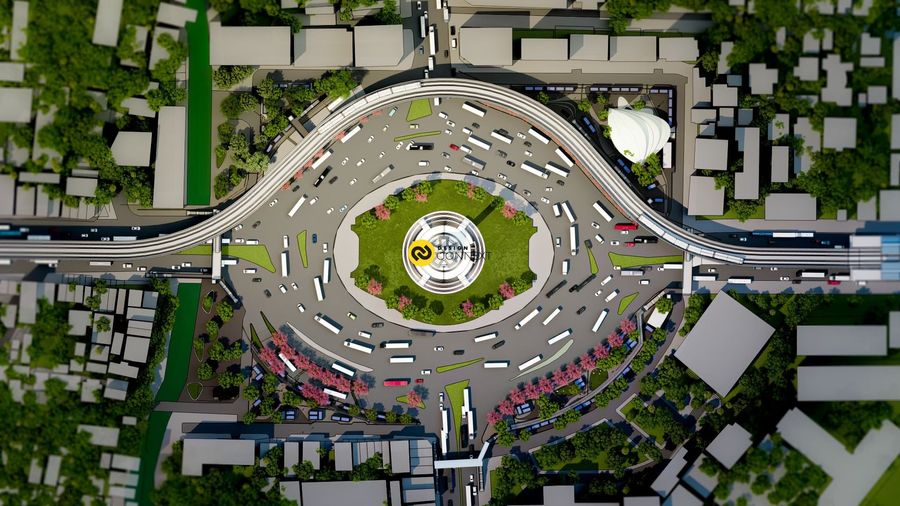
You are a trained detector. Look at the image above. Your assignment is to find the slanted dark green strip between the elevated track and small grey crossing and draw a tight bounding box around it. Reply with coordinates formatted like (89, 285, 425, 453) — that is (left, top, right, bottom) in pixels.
(156, 283, 200, 402)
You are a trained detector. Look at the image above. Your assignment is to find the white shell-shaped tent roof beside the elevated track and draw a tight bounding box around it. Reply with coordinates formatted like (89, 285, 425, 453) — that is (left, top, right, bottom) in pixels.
(609, 109, 672, 163)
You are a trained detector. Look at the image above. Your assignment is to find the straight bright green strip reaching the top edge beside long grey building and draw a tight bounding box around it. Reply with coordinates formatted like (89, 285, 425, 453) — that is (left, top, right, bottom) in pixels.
(187, 0, 212, 206)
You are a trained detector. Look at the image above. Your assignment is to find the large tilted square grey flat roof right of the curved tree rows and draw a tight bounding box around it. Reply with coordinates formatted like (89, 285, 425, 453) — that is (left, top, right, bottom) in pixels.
(675, 292, 775, 397)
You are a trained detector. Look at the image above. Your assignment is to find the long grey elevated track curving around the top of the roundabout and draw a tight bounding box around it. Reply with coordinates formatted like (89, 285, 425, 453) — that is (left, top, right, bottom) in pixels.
(0, 79, 887, 269)
